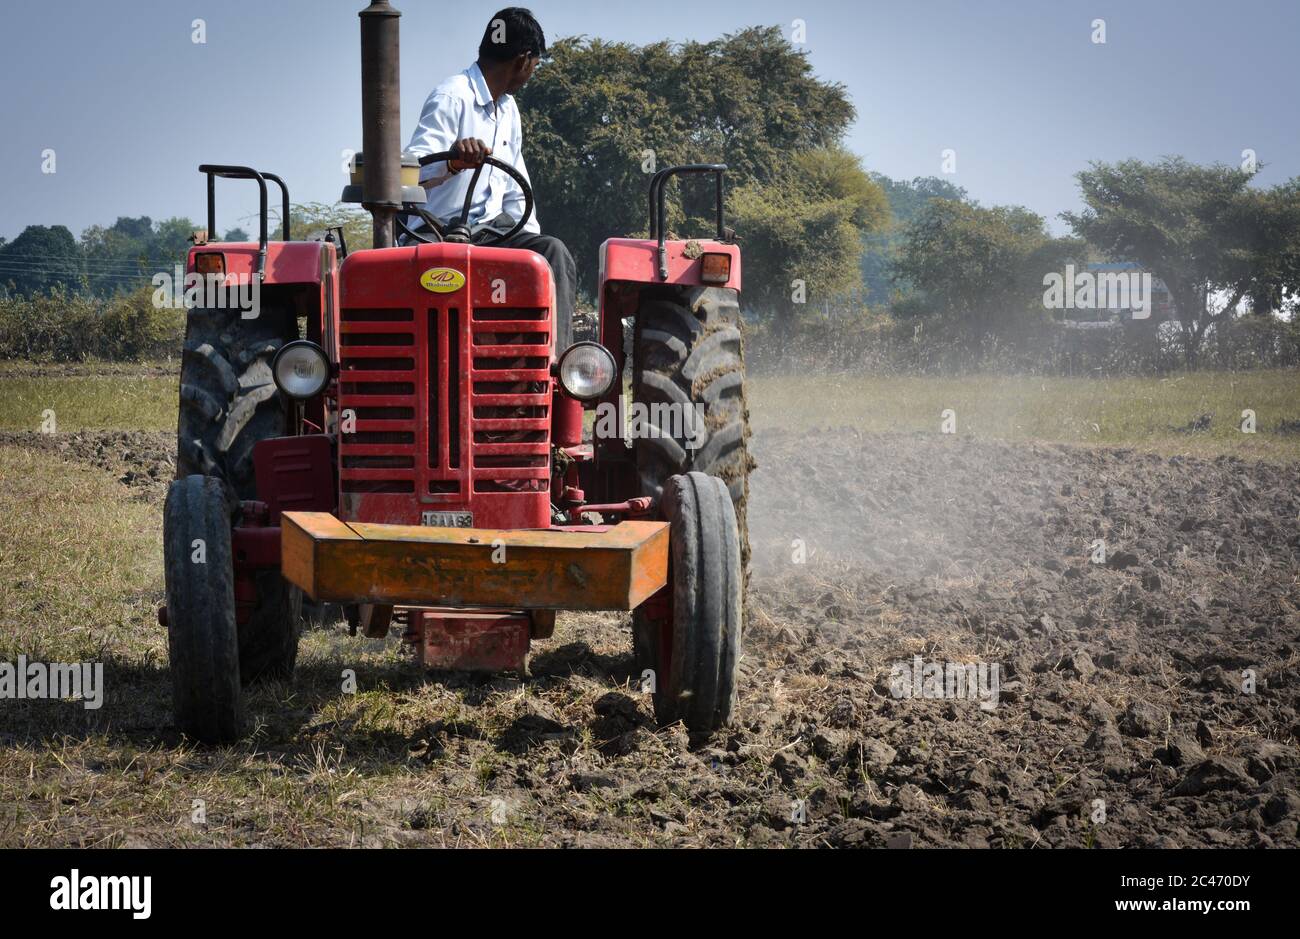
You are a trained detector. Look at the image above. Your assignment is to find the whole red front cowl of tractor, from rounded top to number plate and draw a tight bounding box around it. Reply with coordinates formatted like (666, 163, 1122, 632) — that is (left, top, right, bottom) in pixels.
(338, 245, 554, 528)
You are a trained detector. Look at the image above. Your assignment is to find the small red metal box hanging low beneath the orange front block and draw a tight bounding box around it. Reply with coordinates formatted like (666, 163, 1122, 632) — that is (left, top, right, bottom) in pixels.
(402, 610, 530, 672)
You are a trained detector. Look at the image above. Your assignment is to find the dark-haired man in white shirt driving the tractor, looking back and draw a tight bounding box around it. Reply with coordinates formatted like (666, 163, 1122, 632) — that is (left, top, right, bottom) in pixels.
(407, 7, 577, 349)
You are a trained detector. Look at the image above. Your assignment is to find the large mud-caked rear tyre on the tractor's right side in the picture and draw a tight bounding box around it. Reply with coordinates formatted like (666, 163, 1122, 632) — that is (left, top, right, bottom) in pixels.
(632, 287, 754, 571)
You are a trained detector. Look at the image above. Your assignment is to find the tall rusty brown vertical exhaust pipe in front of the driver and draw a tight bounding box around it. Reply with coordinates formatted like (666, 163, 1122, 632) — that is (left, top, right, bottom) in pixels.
(358, 0, 402, 248)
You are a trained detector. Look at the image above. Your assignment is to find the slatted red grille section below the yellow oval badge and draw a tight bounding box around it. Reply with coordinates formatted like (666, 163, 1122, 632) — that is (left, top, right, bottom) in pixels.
(339, 307, 551, 520)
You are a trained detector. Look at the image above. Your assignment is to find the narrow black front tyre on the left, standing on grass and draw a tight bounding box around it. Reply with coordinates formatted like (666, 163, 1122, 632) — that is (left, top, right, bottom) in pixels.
(163, 476, 243, 744)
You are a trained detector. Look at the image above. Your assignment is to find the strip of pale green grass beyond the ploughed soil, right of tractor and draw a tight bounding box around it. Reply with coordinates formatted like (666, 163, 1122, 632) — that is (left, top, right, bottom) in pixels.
(749, 369, 1300, 460)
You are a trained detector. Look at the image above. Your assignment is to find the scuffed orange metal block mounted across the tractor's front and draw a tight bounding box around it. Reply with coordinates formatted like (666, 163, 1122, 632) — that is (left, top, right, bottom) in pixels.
(281, 512, 668, 610)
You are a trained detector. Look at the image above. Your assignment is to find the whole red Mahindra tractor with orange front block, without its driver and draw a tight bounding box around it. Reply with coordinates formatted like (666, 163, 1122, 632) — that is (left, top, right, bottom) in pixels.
(161, 0, 751, 743)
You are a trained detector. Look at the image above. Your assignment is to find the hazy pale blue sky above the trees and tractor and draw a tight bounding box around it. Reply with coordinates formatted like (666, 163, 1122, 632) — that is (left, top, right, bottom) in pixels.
(0, 0, 1300, 238)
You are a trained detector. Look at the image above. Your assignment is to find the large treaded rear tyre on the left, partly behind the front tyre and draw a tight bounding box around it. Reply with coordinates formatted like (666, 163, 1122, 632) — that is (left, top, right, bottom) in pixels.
(176, 300, 303, 684)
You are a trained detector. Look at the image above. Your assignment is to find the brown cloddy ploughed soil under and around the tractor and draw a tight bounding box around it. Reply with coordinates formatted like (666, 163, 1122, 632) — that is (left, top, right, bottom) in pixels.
(0, 429, 1300, 848)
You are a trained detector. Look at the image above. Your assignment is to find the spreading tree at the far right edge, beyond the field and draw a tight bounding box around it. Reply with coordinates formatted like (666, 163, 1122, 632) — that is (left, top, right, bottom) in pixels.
(1062, 157, 1300, 365)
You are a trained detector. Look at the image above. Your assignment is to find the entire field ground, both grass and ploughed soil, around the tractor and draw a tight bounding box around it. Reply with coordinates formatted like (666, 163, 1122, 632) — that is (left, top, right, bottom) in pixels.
(0, 364, 1300, 848)
